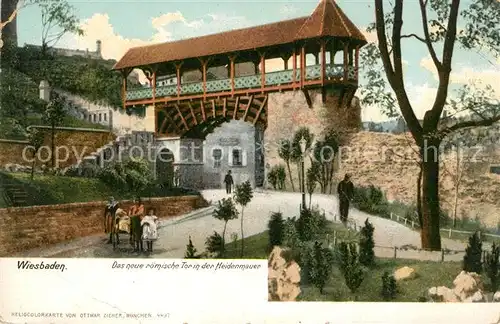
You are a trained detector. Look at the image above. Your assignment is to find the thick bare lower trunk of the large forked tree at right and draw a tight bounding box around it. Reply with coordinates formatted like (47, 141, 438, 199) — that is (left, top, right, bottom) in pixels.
(420, 139, 441, 251)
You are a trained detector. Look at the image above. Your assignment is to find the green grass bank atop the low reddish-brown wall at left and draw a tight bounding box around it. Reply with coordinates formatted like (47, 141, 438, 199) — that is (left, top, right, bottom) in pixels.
(0, 172, 198, 207)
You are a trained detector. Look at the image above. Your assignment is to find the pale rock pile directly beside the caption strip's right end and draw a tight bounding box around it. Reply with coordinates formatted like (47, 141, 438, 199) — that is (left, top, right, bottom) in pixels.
(268, 246, 300, 301)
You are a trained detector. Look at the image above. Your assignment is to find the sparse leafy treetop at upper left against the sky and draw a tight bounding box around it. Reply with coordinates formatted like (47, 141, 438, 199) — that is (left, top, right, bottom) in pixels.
(39, 0, 84, 54)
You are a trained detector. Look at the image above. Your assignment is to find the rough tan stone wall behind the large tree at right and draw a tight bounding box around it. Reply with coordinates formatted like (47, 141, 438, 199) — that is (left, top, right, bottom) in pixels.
(337, 132, 500, 226)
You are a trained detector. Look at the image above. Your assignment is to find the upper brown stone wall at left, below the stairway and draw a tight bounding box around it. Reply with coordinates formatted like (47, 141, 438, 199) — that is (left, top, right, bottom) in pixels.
(0, 127, 116, 168)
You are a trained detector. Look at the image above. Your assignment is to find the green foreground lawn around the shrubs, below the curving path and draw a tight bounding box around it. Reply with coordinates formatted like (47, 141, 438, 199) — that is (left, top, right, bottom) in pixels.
(226, 227, 462, 302)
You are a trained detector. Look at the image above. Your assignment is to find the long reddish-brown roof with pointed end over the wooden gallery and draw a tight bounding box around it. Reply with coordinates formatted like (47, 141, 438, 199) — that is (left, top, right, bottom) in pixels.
(113, 0, 366, 69)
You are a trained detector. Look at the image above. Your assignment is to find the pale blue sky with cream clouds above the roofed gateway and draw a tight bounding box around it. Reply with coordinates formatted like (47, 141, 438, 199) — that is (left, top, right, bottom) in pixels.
(13, 0, 500, 121)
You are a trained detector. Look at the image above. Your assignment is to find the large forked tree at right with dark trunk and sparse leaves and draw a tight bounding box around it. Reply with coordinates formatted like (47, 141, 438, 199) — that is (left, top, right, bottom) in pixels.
(361, 0, 500, 250)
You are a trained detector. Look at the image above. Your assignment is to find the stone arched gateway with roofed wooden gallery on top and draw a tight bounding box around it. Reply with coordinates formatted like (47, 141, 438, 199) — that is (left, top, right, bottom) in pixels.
(114, 0, 366, 187)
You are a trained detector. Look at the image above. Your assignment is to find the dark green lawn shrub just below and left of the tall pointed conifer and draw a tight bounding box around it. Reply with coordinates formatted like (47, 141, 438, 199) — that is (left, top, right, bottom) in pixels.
(339, 242, 364, 293)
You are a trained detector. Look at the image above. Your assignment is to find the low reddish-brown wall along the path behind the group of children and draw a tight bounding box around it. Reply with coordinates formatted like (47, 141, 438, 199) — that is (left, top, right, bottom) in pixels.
(0, 196, 207, 257)
